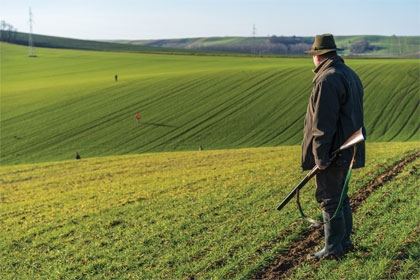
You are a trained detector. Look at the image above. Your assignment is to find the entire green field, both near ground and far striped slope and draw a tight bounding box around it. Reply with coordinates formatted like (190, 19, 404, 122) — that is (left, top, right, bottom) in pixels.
(0, 43, 420, 279)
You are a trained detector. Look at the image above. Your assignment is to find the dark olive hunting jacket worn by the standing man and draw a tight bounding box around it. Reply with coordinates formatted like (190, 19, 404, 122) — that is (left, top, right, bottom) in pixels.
(302, 56, 366, 170)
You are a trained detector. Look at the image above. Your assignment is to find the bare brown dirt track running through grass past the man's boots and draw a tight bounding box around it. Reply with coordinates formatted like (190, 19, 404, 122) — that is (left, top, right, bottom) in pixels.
(255, 152, 420, 279)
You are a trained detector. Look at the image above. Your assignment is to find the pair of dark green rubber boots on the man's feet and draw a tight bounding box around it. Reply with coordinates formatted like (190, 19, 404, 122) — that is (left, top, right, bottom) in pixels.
(308, 211, 346, 260)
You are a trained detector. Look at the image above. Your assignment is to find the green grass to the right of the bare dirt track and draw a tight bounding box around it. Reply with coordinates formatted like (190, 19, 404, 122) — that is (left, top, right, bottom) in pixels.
(292, 153, 420, 279)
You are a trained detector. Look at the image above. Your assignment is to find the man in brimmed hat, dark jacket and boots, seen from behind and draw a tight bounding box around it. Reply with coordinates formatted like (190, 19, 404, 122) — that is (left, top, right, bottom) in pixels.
(302, 34, 366, 260)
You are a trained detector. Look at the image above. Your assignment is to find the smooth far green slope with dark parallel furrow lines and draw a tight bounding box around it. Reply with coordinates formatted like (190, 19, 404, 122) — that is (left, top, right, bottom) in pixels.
(0, 43, 419, 165)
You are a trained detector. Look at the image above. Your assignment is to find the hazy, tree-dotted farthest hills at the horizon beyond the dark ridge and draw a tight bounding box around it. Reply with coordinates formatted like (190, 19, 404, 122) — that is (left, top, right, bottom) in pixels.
(122, 35, 420, 58)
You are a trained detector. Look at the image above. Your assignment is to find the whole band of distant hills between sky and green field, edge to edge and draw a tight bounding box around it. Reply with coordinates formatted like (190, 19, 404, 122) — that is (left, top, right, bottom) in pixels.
(0, 30, 420, 58)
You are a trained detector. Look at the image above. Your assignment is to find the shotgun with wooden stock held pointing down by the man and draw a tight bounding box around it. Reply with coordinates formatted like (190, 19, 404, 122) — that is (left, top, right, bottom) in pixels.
(277, 128, 365, 210)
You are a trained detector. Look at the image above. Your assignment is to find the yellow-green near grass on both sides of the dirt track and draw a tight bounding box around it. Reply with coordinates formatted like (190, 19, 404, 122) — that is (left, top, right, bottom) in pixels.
(0, 142, 420, 279)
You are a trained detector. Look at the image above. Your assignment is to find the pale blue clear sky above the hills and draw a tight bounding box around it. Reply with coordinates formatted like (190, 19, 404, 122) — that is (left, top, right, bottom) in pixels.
(0, 0, 420, 40)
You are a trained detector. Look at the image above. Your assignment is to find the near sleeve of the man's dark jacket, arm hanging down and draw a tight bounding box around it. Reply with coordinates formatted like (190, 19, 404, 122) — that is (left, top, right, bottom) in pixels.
(311, 77, 343, 166)
